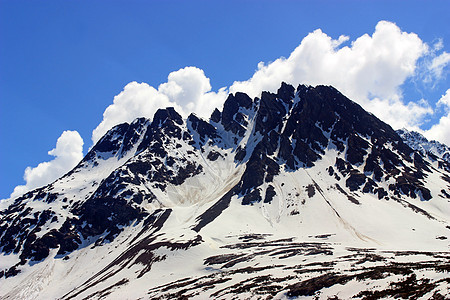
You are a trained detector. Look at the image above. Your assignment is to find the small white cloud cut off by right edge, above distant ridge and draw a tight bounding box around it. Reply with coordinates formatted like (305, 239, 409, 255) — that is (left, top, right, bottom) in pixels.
(424, 89, 450, 145)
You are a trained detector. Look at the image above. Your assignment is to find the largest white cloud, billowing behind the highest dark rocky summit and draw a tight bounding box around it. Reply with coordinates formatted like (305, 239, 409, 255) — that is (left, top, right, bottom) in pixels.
(230, 21, 431, 127)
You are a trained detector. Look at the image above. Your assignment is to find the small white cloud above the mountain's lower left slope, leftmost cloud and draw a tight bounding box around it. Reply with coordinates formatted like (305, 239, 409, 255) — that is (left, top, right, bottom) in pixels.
(11, 130, 83, 198)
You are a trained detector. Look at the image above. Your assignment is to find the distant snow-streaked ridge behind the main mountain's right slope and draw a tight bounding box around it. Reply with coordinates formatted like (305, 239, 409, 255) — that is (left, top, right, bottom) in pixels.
(397, 128, 450, 162)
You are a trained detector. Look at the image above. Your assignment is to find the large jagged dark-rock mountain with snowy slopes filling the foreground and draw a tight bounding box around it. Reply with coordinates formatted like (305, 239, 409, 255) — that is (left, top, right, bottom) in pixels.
(0, 83, 450, 299)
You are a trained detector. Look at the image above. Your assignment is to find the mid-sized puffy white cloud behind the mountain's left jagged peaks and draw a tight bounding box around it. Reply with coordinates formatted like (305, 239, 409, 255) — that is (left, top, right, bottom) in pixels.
(92, 67, 227, 144)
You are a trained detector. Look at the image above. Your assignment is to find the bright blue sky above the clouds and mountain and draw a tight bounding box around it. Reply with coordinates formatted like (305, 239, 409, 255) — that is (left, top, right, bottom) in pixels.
(0, 0, 450, 199)
